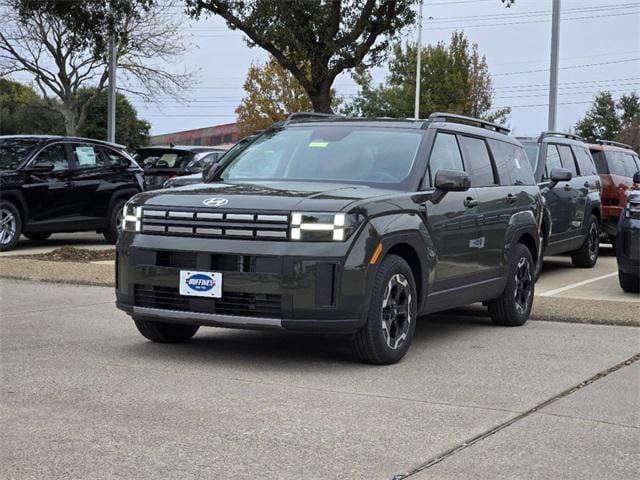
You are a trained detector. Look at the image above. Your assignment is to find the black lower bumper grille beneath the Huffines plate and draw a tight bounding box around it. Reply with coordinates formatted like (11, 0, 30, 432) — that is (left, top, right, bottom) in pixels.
(134, 285, 282, 318)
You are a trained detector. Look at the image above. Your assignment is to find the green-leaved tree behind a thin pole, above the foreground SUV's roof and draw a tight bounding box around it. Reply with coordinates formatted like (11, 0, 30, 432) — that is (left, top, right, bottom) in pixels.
(344, 32, 511, 122)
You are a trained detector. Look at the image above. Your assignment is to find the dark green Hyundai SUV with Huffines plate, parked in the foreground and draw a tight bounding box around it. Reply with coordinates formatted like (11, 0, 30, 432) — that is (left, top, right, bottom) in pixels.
(116, 113, 542, 364)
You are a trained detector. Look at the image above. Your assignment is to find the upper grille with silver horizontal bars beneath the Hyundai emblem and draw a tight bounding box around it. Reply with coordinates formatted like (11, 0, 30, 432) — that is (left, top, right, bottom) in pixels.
(142, 208, 289, 240)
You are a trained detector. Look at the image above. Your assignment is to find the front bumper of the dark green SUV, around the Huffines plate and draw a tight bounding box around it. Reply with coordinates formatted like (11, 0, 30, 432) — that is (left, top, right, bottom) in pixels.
(116, 233, 371, 332)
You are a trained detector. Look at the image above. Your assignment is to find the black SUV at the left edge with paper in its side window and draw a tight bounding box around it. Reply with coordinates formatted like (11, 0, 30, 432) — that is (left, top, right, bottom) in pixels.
(0, 135, 143, 251)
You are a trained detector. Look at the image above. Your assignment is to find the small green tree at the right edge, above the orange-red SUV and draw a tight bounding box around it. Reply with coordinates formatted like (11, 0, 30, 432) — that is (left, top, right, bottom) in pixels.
(575, 91, 640, 150)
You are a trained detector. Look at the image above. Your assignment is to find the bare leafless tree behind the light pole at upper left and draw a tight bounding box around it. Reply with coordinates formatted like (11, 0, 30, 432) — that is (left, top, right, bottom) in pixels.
(0, 1, 193, 135)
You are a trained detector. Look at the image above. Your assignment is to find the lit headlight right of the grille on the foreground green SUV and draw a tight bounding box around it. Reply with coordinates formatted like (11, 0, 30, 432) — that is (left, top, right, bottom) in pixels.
(290, 212, 364, 242)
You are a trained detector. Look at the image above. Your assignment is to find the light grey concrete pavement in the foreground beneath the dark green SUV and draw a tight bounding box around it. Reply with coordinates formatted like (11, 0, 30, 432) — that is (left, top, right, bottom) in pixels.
(0, 280, 640, 479)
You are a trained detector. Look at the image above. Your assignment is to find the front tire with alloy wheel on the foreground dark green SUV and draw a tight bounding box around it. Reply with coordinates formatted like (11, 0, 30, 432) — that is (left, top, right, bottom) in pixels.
(354, 255, 418, 365)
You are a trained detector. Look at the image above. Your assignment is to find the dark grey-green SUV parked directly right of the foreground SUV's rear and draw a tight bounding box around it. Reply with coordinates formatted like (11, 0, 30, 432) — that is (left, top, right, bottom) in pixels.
(519, 132, 602, 268)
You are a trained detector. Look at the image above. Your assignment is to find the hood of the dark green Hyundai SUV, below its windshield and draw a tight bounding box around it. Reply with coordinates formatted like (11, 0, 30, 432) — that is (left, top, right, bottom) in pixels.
(136, 182, 398, 212)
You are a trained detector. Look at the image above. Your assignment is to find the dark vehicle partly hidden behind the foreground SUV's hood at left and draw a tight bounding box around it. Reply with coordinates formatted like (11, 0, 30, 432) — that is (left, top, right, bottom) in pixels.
(133, 145, 227, 190)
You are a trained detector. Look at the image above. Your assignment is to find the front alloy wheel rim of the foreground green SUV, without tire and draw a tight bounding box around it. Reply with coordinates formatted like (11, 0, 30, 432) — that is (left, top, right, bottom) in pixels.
(382, 273, 413, 350)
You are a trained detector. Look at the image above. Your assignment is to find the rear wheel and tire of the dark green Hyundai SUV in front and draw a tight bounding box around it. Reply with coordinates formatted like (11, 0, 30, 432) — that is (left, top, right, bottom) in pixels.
(487, 243, 535, 327)
